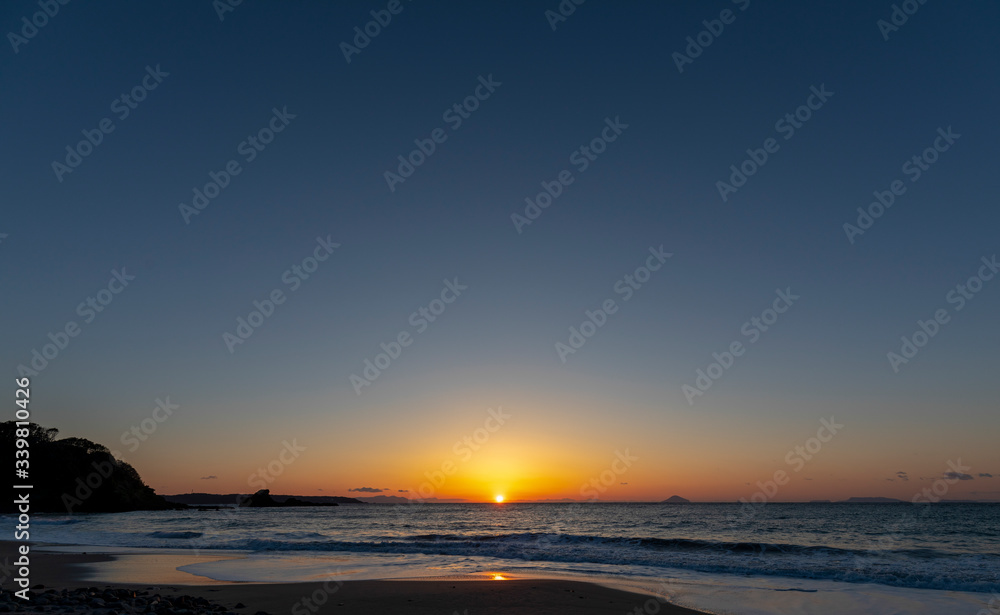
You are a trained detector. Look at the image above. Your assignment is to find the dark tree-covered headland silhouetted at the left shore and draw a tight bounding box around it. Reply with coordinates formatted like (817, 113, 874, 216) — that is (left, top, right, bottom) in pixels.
(0, 421, 176, 513)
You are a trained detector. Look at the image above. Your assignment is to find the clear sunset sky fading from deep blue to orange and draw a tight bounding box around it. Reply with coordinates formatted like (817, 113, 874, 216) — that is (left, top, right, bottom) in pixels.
(0, 0, 1000, 501)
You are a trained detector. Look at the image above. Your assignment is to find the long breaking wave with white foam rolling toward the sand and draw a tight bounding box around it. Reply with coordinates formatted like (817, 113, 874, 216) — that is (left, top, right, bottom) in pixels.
(160, 533, 1000, 592)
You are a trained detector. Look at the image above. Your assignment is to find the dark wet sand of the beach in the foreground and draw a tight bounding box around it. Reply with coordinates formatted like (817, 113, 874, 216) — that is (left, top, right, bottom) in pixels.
(0, 542, 699, 615)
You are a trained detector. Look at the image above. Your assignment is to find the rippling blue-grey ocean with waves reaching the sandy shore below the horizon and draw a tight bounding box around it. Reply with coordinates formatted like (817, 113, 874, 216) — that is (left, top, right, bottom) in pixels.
(17, 503, 1000, 615)
